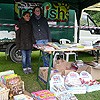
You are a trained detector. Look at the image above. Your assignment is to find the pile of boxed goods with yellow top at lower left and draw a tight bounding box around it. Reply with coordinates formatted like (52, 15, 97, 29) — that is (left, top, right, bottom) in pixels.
(0, 70, 24, 100)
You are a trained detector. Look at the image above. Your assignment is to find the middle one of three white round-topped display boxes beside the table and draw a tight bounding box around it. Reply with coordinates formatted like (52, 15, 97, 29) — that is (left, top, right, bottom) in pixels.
(64, 72, 86, 94)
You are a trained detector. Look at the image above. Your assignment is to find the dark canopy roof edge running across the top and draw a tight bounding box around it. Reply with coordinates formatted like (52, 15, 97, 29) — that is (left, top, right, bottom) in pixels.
(0, 0, 100, 24)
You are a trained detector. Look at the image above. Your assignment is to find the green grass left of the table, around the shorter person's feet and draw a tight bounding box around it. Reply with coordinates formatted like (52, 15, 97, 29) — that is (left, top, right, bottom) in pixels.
(0, 51, 41, 93)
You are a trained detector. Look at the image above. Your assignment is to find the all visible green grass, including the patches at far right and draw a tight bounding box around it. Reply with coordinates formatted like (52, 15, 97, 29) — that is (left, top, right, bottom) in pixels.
(0, 51, 100, 100)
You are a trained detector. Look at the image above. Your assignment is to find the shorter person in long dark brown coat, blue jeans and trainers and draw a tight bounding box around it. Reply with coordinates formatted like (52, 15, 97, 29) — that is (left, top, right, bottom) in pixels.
(15, 11, 33, 74)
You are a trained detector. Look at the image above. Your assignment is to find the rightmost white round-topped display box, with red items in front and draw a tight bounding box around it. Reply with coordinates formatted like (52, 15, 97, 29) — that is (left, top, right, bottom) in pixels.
(80, 71, 100, 92)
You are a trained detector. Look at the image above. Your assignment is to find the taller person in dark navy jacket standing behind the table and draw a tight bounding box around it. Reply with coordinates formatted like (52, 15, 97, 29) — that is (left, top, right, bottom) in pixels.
(31, 6, 51, 67)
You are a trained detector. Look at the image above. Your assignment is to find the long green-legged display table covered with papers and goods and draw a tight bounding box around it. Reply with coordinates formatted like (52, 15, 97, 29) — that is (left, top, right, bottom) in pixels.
(33, 42, 100, 89)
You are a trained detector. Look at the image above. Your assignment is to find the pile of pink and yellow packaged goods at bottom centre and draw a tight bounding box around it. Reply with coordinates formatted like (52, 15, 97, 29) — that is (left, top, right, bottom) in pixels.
(31, 90, 57, 100)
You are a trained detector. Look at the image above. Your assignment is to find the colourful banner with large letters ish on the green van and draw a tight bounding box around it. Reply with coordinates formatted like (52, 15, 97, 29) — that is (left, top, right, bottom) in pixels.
(15, 2, 69, 21)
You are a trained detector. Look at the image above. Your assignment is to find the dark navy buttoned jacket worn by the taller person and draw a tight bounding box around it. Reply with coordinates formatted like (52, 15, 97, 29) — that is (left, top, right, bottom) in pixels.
(31, 15, 51, 41)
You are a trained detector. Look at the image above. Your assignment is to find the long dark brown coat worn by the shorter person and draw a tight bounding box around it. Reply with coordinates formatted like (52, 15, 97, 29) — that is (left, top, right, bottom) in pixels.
(16, 18, 33, 50)
